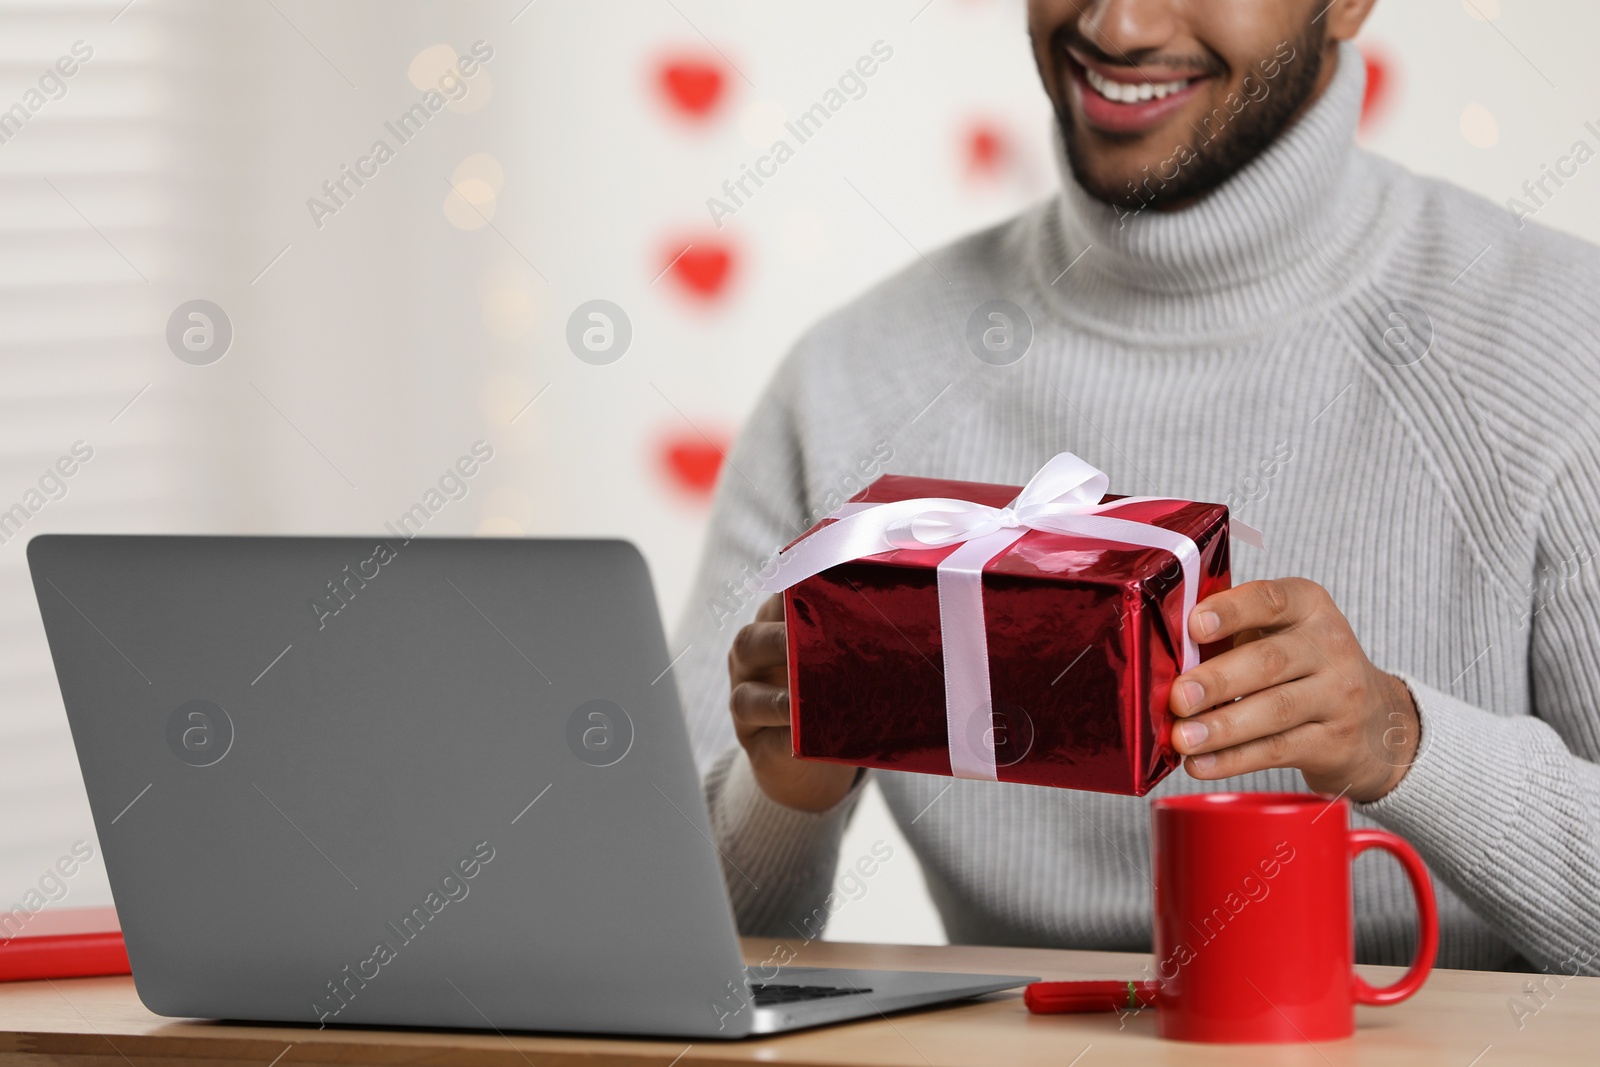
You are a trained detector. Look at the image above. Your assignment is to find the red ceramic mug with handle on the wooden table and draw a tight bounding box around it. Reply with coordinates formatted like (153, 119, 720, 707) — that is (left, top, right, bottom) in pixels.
(1150, 793, 1438, 1043)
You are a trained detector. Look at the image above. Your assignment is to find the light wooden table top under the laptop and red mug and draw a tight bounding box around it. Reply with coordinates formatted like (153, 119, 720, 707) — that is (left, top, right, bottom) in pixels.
(0, 939, 1600, 1067)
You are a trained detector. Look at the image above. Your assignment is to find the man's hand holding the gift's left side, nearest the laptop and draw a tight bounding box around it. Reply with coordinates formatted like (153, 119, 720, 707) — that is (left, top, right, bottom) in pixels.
(728, 597, 856, 811)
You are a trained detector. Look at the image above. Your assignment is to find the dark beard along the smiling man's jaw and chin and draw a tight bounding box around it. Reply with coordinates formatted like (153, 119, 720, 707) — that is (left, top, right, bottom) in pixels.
(1056, 22, 1326, 210)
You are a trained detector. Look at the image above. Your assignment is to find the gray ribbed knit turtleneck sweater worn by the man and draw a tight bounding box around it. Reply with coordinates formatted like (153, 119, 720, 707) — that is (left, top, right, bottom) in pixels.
(677, 46, 1600, 971)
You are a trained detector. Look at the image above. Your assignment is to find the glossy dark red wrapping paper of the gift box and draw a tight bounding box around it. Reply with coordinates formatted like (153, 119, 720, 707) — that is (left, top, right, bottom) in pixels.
(784, 475, 1230, 797)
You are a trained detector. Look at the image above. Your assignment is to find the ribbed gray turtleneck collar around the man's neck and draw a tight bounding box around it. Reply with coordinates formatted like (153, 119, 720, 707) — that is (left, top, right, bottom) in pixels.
(1035, 43, 1384, 336)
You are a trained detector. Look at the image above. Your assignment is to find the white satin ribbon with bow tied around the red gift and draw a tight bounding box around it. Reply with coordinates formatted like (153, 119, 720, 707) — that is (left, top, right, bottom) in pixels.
(758, 453, 1200, 781)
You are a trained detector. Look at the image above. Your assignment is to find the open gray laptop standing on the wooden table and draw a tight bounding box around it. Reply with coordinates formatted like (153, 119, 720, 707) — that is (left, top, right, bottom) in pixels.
(27, 534, 1034, 1040)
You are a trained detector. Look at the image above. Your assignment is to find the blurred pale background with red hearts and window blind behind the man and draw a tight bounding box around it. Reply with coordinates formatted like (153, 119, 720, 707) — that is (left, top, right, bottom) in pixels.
(0, 0, 1600, 944)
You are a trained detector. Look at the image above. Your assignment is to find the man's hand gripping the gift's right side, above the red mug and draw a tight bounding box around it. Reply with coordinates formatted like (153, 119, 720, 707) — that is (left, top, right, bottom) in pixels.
(1170, 577, 1421, 801)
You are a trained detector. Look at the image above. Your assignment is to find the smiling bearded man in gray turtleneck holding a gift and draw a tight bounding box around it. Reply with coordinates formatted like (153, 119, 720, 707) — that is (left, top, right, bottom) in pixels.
(678, 0, 1600, 971)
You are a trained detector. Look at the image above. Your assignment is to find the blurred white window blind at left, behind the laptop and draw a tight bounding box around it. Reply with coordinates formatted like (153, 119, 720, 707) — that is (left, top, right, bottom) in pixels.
(0, 0, 208, 909)
